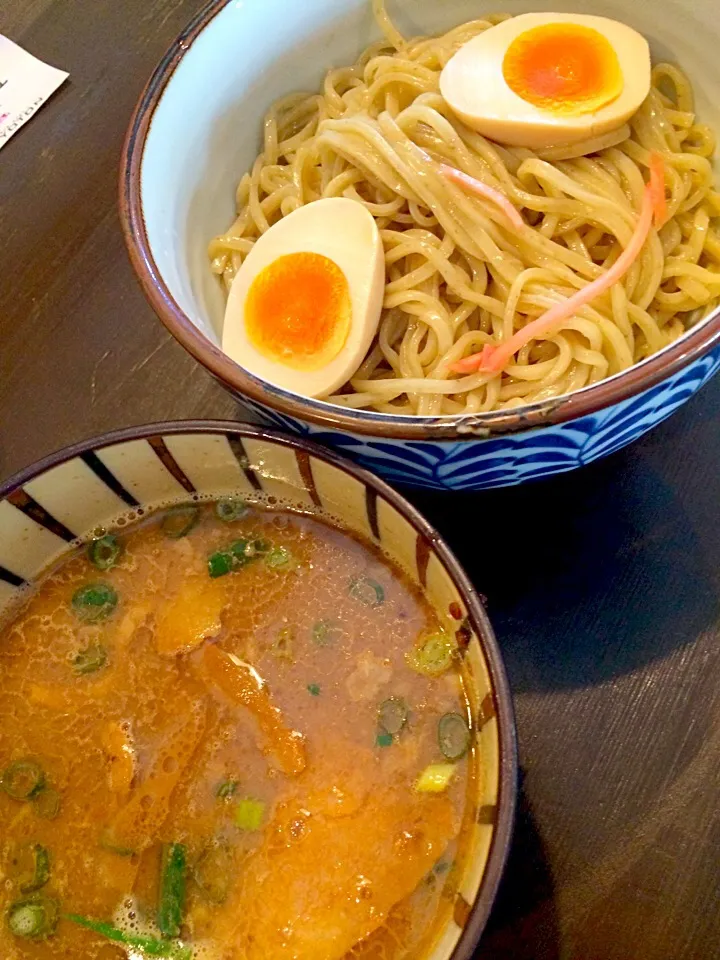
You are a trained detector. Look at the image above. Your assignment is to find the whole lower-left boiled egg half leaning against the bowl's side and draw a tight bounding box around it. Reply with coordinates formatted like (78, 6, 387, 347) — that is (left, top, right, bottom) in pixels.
(222, 197, 385, 397)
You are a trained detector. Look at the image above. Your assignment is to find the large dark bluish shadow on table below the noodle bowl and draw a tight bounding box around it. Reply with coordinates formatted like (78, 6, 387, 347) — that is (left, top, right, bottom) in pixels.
(408, 438, 718, 692)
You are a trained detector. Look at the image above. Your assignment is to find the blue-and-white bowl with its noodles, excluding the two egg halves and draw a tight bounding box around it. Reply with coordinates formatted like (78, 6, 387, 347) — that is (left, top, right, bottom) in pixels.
(120, 0, 720, 489)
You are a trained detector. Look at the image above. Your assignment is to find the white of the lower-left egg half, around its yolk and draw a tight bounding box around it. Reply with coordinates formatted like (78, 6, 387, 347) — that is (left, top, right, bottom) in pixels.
(222, 197, 385, 397)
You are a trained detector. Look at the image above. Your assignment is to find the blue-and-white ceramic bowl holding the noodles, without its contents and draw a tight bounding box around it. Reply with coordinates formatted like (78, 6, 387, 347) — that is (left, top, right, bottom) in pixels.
(120, 0, 720, 490)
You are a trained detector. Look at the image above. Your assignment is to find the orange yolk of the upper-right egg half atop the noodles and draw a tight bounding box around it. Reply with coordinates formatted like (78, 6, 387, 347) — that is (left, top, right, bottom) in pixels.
(503, 23, 623, 115)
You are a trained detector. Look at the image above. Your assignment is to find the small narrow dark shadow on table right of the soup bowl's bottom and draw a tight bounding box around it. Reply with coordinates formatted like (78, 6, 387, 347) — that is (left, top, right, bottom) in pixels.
(474, 788, 560, 960)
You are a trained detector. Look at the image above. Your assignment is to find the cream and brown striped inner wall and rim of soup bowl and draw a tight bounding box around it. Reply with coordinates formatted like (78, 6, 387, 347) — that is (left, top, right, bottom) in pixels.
(0, 422, 517, 960)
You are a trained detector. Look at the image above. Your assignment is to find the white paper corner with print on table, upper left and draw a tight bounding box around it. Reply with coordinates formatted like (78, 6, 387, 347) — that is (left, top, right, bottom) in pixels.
(0, 34, 68, 147)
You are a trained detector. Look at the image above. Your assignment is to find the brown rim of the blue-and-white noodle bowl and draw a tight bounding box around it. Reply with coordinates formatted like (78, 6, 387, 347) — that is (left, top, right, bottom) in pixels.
(119, 0, 720, 442)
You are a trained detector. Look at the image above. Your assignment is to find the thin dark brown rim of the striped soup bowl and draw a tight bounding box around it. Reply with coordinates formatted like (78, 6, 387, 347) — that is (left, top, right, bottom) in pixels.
(0, 419, 518, 960)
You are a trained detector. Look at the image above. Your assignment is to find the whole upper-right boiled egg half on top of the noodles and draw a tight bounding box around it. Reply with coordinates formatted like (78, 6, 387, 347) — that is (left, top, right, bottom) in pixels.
(440, 13, 650, 148)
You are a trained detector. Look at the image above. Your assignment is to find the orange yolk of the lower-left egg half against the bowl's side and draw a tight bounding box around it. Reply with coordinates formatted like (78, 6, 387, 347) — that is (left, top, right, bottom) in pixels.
(245, 253, 352, 370)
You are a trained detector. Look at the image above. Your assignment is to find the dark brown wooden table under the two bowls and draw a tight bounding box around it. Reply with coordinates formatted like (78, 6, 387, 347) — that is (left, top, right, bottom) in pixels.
(0, 0, 720, 960)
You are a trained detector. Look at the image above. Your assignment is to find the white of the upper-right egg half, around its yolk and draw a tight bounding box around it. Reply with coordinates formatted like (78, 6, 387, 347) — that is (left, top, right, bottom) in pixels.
(440, 13, 650, 149)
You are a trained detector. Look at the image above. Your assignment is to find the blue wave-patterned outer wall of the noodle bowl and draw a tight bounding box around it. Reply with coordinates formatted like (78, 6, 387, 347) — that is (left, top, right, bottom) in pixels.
(243, 347, 720, 490)
